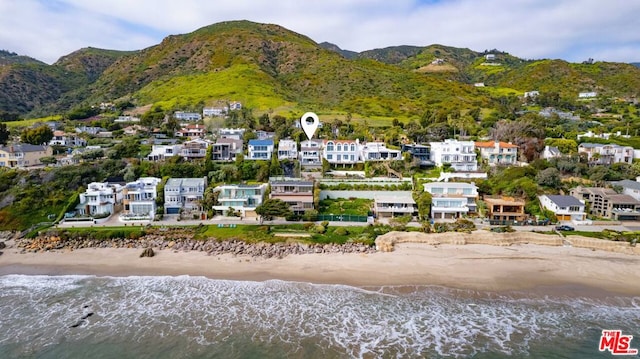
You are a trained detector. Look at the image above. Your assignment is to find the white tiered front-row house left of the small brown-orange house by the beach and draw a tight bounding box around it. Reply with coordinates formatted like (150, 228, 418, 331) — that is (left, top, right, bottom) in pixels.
(424, 182, 478, 219)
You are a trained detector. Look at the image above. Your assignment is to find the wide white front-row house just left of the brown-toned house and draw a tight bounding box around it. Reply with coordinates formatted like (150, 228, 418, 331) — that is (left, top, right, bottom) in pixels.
(213, 183, 267, 217)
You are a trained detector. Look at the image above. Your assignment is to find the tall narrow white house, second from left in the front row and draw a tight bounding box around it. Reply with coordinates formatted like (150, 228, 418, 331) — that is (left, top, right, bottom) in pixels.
(120, 177, 162, 221)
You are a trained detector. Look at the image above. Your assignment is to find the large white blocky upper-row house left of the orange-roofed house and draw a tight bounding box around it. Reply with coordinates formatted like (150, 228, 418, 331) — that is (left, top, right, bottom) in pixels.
(430, 139, 478, 172)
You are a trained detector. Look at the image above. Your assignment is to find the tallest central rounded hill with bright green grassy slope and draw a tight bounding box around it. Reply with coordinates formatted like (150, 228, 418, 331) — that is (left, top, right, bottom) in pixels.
(94, 21, 484, 118)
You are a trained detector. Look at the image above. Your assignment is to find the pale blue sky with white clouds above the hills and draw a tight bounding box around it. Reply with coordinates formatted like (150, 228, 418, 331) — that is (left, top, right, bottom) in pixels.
(0, 0, 640, 63)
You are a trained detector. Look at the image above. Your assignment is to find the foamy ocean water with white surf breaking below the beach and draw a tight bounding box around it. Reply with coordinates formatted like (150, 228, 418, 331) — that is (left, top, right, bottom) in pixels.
(0, 275, 640, 359)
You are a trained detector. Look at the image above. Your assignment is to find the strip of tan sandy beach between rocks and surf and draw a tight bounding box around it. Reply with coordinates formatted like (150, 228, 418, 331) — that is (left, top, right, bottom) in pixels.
(0, 243, 640, 295)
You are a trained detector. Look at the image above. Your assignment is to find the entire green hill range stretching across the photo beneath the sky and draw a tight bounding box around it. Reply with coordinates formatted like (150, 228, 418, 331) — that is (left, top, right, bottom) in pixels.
(0, 21, 640, 119)
